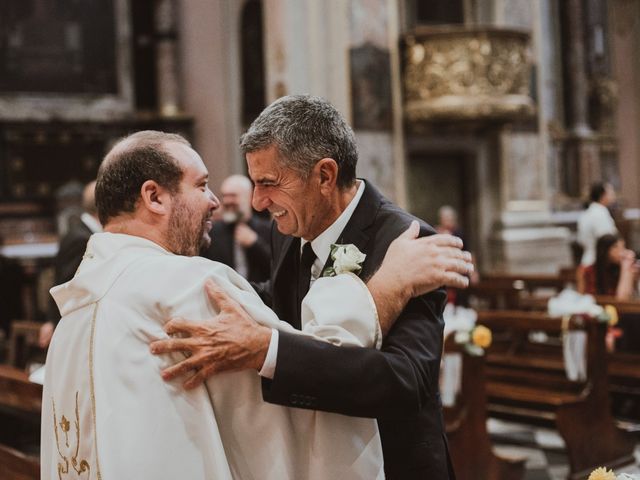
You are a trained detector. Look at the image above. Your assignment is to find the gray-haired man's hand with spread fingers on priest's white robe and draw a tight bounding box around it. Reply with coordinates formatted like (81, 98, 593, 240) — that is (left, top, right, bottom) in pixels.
(151, 280, 271, 389)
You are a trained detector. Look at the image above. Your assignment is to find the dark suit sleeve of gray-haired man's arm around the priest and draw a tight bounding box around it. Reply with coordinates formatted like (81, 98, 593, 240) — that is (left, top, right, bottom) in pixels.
(263, 289, 446, 417)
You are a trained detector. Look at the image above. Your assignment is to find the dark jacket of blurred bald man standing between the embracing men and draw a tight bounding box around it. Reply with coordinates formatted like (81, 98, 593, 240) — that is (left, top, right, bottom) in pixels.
(202, 215, 271, 282)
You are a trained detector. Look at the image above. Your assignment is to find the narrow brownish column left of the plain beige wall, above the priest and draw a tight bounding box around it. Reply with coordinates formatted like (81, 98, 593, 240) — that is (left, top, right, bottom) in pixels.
(155, 0, 180, 116)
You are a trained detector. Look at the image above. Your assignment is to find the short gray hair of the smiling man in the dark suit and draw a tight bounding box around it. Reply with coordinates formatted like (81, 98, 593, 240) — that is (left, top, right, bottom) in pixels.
(240, 95, 358, 188)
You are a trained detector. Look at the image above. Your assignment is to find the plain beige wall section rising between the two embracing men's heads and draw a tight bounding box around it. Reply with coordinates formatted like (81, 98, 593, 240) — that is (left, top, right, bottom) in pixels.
(179, 0, 244, 189)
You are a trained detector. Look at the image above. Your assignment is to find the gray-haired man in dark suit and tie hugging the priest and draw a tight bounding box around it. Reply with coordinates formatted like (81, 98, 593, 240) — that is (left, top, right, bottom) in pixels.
(154, 96, 470, 480)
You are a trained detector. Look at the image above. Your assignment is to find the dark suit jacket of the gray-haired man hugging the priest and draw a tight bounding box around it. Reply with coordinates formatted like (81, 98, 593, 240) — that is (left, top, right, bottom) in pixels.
(261, 183, 454, 480)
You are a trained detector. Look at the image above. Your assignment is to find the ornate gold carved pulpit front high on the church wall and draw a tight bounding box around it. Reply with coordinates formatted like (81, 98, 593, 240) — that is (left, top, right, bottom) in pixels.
(403, 26, 534, 121)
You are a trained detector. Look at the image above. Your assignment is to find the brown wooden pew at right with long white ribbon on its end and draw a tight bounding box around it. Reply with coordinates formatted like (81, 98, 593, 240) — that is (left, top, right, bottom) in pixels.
(478, 311, 635, 479)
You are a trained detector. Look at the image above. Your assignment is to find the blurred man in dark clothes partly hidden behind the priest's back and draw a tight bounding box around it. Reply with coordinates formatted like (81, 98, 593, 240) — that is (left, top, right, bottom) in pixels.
(38, 181, 102, 348)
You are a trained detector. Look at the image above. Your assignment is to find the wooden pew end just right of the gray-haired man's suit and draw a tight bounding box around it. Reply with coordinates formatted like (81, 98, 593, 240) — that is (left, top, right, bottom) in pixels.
(443, 335, 524, 480)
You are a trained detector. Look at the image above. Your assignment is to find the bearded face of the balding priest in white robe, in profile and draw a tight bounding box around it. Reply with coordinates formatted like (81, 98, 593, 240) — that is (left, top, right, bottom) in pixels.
(166, 143, 220, 256)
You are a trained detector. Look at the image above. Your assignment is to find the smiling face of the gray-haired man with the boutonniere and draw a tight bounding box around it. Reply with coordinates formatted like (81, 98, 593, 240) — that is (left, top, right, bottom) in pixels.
(247, 146, 330, 240)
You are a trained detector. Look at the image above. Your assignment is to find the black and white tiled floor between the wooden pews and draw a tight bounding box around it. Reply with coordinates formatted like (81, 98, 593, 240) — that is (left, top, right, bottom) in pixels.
(488, 419, 640, 480)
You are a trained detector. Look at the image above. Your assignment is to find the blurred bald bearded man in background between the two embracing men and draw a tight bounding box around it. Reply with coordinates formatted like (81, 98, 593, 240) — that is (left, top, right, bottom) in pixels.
(202, 175, 271, 282)
